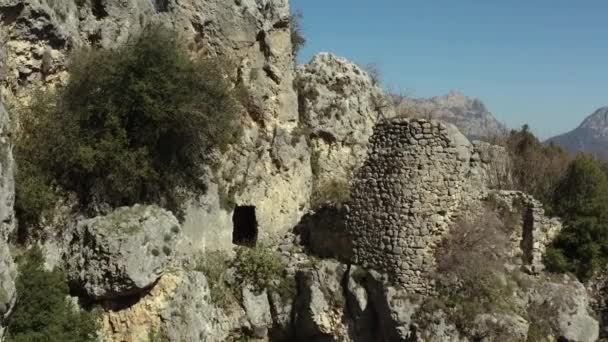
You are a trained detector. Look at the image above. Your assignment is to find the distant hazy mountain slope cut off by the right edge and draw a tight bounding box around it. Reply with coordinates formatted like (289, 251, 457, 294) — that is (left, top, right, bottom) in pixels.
(547, 107, 608, 160)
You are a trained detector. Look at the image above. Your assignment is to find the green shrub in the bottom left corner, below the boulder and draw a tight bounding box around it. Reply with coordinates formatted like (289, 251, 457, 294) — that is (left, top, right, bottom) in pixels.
(7, 248, 97, 342)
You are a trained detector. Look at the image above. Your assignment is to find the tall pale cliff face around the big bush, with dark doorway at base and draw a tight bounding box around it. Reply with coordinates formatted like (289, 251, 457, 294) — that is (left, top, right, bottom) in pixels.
(0, 0, 312, 249)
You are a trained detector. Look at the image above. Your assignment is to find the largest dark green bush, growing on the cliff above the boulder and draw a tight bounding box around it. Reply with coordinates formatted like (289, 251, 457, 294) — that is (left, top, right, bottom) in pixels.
(16, 26, 241, 227)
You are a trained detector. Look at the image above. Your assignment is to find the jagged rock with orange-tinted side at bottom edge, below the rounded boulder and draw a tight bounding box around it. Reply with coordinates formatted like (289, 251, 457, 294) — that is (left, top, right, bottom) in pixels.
(101, 271, 247, 342)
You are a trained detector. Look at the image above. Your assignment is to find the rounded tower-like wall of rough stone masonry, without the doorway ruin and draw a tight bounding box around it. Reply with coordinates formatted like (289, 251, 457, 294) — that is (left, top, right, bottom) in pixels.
(347, 119, 471, 292)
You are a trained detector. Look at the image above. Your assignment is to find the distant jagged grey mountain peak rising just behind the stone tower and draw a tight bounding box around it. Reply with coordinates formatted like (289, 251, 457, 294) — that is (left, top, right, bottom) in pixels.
(405, 91, 506, 139)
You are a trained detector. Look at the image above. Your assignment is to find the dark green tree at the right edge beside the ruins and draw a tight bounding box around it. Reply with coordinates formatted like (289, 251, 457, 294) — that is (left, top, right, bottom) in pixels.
(546, 155, 608, 280)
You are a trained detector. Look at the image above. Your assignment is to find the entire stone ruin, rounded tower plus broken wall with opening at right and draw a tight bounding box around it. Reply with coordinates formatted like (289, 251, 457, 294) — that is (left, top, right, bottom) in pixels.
(346, 118, 561, 293)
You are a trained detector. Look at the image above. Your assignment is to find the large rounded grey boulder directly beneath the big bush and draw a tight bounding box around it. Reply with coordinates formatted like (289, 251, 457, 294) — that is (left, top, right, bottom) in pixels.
(66, 205, 181, 299)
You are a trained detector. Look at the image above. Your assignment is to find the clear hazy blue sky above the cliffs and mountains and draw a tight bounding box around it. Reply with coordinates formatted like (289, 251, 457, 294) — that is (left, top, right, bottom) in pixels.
(291, 0, 608, 137)
